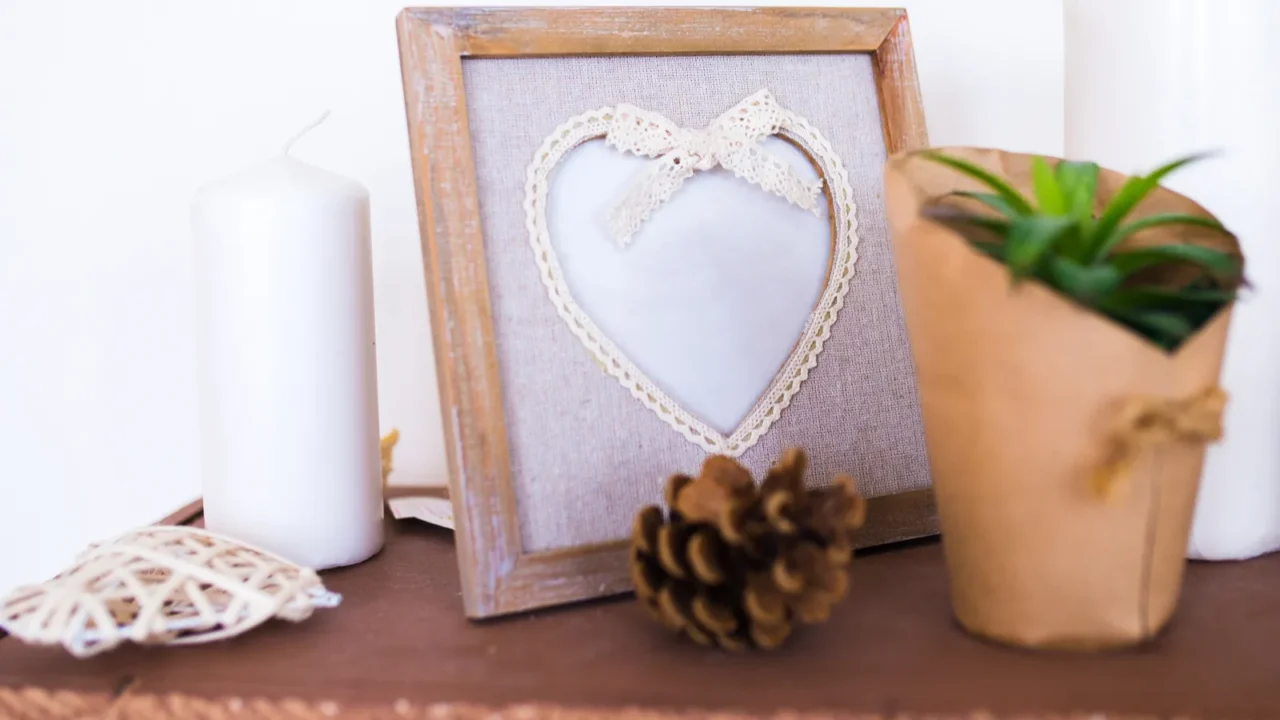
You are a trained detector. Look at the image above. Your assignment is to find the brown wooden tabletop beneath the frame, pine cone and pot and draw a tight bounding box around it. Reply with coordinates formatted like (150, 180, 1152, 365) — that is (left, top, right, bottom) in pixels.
(0, 509, 1280, 717)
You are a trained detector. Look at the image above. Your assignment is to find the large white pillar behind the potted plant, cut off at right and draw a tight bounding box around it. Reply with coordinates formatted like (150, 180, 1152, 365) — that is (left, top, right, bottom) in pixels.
(1064, 0, 1280, 559)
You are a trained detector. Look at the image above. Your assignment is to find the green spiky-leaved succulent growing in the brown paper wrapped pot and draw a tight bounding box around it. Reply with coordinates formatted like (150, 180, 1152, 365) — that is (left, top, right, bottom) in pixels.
(920, 150, 1243, 351)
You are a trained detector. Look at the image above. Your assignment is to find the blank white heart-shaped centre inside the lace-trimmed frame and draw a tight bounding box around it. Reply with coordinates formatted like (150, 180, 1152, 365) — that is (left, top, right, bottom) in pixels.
(547, 137, 832, 436)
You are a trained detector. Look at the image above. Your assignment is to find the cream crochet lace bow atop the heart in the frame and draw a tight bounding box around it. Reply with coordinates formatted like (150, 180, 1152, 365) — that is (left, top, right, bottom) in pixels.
(604, 90, 822, 246)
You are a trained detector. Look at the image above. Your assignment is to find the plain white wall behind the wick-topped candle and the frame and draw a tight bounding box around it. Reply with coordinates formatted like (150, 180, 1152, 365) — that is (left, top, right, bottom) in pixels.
(0, 0, 1062, 592)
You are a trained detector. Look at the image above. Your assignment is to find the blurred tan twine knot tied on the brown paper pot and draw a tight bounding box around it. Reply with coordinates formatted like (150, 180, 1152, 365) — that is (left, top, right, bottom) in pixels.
(1093, 387, 1226, 500)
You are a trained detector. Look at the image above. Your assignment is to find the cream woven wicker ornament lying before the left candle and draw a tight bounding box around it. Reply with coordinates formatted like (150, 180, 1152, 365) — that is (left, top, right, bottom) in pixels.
(0, 527, 342, 657)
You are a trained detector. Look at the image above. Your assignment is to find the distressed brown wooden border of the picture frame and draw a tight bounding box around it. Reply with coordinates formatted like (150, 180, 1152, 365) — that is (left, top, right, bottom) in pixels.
(397, 8, 936, 618)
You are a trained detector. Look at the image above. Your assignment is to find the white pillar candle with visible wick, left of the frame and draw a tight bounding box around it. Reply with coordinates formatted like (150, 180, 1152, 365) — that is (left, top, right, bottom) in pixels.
(192, 118, 383, 569)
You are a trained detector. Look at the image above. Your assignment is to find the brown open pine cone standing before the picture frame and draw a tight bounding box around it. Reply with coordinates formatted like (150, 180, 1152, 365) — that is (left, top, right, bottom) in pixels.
(631, 448, 867, 650)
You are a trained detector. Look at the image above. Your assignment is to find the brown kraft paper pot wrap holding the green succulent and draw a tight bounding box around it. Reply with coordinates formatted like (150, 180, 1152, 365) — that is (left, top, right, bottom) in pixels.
(886, 149, 1239, 648)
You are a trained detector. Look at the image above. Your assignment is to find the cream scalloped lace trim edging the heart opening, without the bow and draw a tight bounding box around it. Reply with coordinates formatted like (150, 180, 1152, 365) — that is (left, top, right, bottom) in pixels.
(525, 101, 858, 457)
